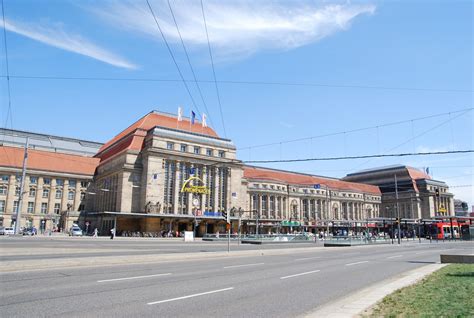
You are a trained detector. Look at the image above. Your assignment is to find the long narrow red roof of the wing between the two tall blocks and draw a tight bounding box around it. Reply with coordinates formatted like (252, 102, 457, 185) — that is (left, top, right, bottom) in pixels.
(244, 166, 381, 195)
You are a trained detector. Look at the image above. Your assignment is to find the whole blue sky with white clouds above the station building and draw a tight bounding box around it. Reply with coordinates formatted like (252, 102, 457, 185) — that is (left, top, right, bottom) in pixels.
(0, 0, 474, 204)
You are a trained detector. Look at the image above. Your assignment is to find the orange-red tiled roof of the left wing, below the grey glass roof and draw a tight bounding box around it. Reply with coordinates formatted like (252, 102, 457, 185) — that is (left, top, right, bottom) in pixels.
(0, 146, 99, 176)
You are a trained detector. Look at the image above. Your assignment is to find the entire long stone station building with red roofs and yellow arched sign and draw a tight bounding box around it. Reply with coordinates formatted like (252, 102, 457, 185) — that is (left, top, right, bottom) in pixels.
(0, 111, 460, 235)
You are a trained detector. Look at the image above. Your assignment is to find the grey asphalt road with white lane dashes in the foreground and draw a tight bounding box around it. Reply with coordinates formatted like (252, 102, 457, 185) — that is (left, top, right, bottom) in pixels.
(0, 242, 473, 317)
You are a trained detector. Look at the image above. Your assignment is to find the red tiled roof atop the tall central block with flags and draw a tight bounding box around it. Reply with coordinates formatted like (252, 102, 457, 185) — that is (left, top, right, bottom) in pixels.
(96, 112, 218, 160)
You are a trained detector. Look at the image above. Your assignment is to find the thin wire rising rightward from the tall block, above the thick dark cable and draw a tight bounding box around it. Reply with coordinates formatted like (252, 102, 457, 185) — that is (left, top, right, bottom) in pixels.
(241, 107, 474, 150)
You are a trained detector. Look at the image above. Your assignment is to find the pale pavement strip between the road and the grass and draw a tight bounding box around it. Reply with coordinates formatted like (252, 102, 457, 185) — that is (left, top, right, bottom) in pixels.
(304, 264, 447, 318)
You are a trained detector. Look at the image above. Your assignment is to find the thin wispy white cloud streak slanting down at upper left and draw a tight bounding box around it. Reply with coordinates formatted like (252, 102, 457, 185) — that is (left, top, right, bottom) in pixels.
(5, 20, 137, 69)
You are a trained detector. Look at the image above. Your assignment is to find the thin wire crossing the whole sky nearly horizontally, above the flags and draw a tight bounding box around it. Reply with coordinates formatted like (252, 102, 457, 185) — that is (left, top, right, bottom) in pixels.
(0, 75, 474, 93)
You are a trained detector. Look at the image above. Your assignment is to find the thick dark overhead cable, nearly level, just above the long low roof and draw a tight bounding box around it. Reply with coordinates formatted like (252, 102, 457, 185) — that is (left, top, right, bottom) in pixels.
(243, 150, 474, 163)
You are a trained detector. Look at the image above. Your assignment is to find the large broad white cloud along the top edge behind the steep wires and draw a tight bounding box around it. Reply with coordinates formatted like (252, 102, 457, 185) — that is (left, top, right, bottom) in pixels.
(89, 0, 375, 58)
